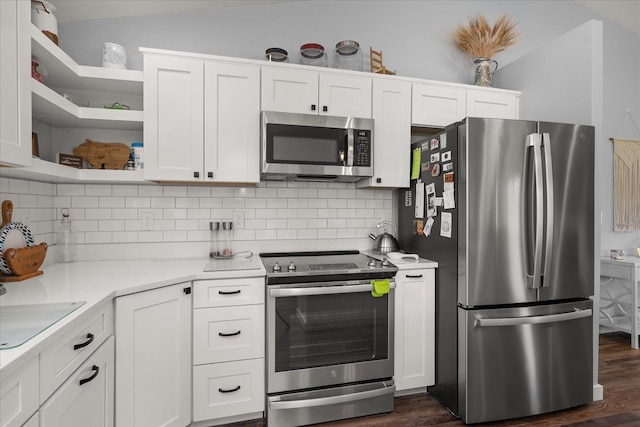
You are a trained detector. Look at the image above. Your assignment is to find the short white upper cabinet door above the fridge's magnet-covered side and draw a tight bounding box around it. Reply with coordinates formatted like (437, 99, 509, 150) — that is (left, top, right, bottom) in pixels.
(411, 83, 467, 127)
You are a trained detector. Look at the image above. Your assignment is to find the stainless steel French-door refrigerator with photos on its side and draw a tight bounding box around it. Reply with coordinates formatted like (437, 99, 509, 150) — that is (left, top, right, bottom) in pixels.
(398, 118, 595, 423)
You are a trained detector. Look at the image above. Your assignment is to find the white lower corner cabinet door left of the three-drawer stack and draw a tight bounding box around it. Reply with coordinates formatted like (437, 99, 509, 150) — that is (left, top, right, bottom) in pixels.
(115, 282, 191, 427)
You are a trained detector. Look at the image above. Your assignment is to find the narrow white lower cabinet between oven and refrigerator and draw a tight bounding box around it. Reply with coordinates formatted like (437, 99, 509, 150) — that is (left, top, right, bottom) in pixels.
(394, 268, 435, 394)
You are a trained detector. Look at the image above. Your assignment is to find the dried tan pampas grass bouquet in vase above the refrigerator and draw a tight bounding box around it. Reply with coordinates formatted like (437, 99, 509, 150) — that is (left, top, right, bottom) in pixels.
(453, 13, 518, 59)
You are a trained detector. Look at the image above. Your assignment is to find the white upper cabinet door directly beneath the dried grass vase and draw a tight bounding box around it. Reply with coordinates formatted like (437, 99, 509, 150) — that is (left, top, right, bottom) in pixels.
(467, 88, 520, 119)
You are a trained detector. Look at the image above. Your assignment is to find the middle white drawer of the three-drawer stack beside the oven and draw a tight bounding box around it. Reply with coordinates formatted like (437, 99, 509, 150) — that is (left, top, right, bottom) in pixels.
(193, 304, 265, 365)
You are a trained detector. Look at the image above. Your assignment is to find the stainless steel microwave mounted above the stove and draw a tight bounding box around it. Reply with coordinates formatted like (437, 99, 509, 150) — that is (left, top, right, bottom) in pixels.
(260, 111, 374, 182)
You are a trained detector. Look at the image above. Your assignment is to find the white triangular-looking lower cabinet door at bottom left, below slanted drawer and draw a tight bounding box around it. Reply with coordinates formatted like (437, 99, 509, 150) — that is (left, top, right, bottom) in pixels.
(40, 337, 114, 427)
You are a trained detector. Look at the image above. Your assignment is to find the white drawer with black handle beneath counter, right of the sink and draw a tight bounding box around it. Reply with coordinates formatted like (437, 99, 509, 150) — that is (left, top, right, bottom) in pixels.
(40, 302, 113, 404)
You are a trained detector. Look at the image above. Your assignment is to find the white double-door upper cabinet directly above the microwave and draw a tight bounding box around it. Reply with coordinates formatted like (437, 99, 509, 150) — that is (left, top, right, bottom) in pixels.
(262, 66, 371, 119)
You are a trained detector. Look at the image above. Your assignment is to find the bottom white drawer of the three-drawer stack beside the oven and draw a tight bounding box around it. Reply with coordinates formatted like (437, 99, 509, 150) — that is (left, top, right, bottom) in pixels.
(193, 359, 265, 421)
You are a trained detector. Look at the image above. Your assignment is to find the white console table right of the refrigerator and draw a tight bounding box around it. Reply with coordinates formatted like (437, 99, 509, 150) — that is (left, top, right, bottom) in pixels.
(600, 256, 640, 349)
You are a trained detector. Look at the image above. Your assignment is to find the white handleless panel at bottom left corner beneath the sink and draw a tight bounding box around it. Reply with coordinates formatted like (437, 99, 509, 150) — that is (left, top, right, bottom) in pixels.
(0, 356, 39, 427)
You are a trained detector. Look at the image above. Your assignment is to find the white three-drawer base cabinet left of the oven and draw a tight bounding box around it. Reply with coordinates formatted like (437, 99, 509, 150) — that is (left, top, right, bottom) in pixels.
(193, 277, 265, 425)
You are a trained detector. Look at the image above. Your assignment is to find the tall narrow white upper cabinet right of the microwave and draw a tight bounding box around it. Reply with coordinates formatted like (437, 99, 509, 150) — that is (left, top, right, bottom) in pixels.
(357, 78, 411, 188)
